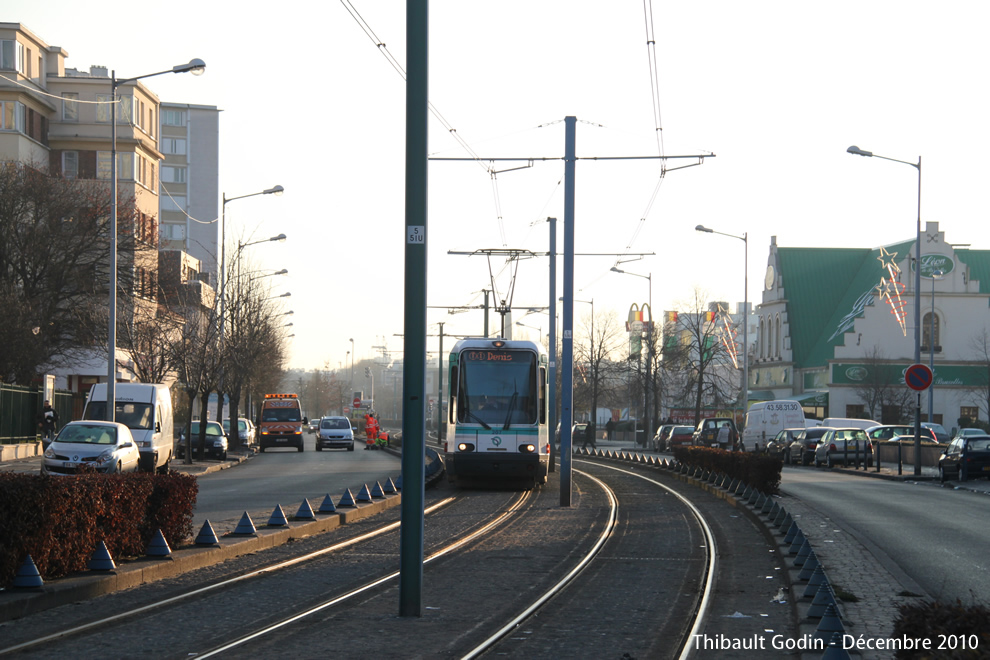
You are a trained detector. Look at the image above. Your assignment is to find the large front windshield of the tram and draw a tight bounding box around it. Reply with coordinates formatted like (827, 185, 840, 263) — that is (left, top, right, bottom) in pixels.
(457, 349, 539, 428)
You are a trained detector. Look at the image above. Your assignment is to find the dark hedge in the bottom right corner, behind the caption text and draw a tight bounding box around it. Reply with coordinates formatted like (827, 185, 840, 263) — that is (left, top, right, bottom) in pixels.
(892, 600, 990, 660)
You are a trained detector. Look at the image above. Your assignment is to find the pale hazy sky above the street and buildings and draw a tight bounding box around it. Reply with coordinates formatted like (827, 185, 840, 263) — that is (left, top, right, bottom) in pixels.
(7, 0, 990, 368)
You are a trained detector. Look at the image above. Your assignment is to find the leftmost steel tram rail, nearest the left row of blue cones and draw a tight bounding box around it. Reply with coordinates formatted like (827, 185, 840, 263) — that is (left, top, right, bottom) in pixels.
(0, 497, 457, 655)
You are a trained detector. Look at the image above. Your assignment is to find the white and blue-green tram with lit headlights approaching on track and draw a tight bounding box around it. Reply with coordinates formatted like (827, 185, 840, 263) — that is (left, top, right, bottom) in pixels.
(444, 338, 550, 487)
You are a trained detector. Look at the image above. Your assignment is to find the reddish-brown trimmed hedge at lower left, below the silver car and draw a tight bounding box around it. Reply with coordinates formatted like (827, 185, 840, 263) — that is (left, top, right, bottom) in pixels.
(0, 472, 199, 586)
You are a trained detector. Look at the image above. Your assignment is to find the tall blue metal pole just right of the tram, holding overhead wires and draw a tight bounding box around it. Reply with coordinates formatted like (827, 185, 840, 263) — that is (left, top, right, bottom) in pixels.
(560, 117, 577, 506)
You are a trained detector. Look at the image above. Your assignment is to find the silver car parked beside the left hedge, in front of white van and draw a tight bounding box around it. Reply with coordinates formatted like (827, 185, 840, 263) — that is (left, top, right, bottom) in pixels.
(41, 420, 141, 474)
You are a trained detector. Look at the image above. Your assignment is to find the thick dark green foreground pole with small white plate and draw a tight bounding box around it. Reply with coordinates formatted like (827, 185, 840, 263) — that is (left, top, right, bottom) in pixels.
(399, 0, 429, 616)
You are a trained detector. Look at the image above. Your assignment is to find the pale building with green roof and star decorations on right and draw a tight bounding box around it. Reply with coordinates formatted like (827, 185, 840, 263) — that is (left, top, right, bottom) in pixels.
(749, 222, 990, 429)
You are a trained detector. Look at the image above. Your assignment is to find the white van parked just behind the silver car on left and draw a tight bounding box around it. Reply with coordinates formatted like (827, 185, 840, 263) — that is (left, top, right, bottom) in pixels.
(83, 383, 174, 474)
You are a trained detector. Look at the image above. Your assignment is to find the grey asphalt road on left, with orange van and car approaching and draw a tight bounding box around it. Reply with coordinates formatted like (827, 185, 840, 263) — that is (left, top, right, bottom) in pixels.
(193, 435, 402, 534)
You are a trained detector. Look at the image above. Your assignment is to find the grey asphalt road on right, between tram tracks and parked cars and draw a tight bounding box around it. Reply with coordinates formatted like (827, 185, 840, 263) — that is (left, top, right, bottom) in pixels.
(781, 467, 990, 603)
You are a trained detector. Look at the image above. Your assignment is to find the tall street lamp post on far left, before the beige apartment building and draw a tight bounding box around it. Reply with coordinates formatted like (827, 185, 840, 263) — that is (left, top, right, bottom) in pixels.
(106, 59, 206, 422)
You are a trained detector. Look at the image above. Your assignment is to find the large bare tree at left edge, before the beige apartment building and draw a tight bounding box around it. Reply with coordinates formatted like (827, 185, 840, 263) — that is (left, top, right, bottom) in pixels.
(0, 162, 135, 383)
